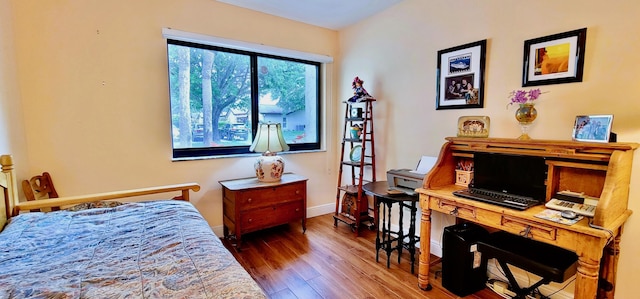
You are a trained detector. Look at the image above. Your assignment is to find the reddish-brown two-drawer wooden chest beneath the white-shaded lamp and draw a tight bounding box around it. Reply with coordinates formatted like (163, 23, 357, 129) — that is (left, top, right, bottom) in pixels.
(219, 173, 307, 250)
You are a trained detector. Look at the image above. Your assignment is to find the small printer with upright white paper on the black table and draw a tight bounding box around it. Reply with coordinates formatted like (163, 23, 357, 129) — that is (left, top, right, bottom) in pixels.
(387, 156, 437, 196)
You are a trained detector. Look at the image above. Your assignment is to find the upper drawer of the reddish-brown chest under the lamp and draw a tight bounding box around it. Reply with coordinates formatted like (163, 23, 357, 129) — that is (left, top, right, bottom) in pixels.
(236, 182, 306, 211)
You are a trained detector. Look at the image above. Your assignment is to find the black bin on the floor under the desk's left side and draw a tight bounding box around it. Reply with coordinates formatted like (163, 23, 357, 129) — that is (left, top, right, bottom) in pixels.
(442, 223, 489, 297)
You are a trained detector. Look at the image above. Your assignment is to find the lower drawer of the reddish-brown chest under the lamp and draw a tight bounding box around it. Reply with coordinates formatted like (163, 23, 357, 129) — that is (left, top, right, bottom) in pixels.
(240, 200, 304, 234)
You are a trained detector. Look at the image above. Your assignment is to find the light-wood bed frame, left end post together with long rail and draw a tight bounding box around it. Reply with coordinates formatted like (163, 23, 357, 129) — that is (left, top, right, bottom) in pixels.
(0, 155, 200, 230)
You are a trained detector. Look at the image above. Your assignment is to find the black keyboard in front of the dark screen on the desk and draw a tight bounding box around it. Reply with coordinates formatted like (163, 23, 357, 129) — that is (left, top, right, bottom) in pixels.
(453, 188, 541, 211)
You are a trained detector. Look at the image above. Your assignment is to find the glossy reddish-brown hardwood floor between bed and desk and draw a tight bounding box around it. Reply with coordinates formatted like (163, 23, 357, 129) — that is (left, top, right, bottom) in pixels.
(224, 214, 501, 299)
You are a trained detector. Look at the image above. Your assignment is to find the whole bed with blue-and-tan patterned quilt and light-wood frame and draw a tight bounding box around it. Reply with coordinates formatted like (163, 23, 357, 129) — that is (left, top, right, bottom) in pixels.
(0, 155, 266, 298)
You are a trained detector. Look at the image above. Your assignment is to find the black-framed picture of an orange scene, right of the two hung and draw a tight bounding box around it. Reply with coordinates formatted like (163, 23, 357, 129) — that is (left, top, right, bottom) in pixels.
(522, 28, 587, 86)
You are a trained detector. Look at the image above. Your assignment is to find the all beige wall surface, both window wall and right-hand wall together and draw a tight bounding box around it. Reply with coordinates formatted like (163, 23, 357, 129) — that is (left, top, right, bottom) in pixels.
(5, 0, 640, 298)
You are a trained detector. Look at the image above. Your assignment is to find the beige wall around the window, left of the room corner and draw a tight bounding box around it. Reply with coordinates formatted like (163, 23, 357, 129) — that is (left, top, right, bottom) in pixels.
(7, 0, 338, 227)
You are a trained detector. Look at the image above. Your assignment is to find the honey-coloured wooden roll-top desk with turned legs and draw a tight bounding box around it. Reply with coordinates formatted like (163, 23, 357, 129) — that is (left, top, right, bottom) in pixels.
(416, 137, 638, 298)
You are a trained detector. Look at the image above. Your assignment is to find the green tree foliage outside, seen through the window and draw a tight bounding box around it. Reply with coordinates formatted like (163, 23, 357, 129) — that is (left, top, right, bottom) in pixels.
(167, 44, 316, 148)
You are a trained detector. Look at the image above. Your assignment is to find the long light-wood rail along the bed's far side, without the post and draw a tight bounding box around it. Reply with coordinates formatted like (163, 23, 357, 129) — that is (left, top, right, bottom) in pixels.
(12, 183, 200, 216)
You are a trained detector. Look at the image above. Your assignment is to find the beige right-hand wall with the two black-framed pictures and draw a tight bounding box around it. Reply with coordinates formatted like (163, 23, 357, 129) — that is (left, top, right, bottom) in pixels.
(337, 0, 640, 298)
